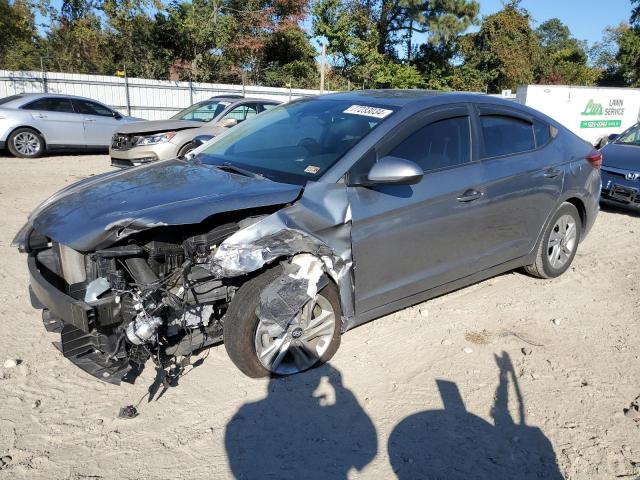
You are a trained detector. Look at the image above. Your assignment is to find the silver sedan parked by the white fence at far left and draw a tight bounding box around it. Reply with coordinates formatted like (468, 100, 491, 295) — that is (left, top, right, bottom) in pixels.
(0, 93, 142, 158)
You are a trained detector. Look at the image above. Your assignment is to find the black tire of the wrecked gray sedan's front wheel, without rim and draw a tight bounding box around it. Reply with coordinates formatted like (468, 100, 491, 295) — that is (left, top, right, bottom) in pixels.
(223, 267, 342, 378)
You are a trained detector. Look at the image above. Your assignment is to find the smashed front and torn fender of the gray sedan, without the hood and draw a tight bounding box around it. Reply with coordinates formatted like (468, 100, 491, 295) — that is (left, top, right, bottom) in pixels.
(16, 189, 353, 384)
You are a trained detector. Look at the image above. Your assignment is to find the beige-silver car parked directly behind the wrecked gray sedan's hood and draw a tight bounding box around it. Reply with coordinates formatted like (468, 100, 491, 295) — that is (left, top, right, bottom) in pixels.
(109, 95, 280, 167)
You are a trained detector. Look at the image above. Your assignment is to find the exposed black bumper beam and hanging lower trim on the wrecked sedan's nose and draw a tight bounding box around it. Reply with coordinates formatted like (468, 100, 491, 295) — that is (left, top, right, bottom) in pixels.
(27, 252, 142, 385)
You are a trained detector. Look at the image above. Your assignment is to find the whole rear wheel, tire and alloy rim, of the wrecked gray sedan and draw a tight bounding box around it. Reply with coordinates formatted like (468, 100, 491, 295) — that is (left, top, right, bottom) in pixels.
(525, 203, 582, 278)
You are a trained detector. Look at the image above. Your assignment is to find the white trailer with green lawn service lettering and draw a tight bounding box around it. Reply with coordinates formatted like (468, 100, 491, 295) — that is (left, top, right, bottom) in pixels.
(516, 85, 640, 147)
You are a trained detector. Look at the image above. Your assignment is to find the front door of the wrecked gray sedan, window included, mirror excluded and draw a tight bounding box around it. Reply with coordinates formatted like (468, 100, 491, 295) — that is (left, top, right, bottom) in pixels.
(348, 105, 486, 314)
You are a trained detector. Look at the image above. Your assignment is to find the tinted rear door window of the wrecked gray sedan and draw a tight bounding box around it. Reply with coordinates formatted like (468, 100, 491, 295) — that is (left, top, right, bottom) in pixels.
(480, 115, 536, 158)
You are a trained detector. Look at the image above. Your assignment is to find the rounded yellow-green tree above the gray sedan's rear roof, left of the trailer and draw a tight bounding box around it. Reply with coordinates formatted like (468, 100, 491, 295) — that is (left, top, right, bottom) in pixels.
(460, 1, 542, 93)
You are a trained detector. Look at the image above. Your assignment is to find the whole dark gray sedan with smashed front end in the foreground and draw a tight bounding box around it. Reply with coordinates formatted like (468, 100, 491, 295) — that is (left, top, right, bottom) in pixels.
(14, 91, 601, 383)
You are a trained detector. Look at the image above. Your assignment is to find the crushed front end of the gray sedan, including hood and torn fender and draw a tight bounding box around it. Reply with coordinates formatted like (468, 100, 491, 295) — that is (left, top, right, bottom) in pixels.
(14, 162, 354, 384)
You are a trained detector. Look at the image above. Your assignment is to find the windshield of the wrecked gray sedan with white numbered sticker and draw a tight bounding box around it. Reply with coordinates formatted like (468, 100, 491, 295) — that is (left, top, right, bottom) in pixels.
(196, 98, 393, 185)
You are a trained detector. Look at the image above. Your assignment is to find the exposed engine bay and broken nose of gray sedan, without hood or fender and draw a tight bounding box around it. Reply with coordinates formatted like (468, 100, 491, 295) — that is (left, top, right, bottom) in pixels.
(21, 219, 244, 384)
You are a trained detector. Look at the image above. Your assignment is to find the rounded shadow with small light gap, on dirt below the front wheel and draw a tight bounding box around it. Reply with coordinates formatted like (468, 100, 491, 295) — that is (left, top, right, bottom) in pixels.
(225, 364, 378, 480)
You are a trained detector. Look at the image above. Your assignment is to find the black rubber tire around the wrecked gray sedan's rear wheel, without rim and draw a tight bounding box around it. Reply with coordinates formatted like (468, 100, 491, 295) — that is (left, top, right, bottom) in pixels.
(525, 202, 582, 278)
